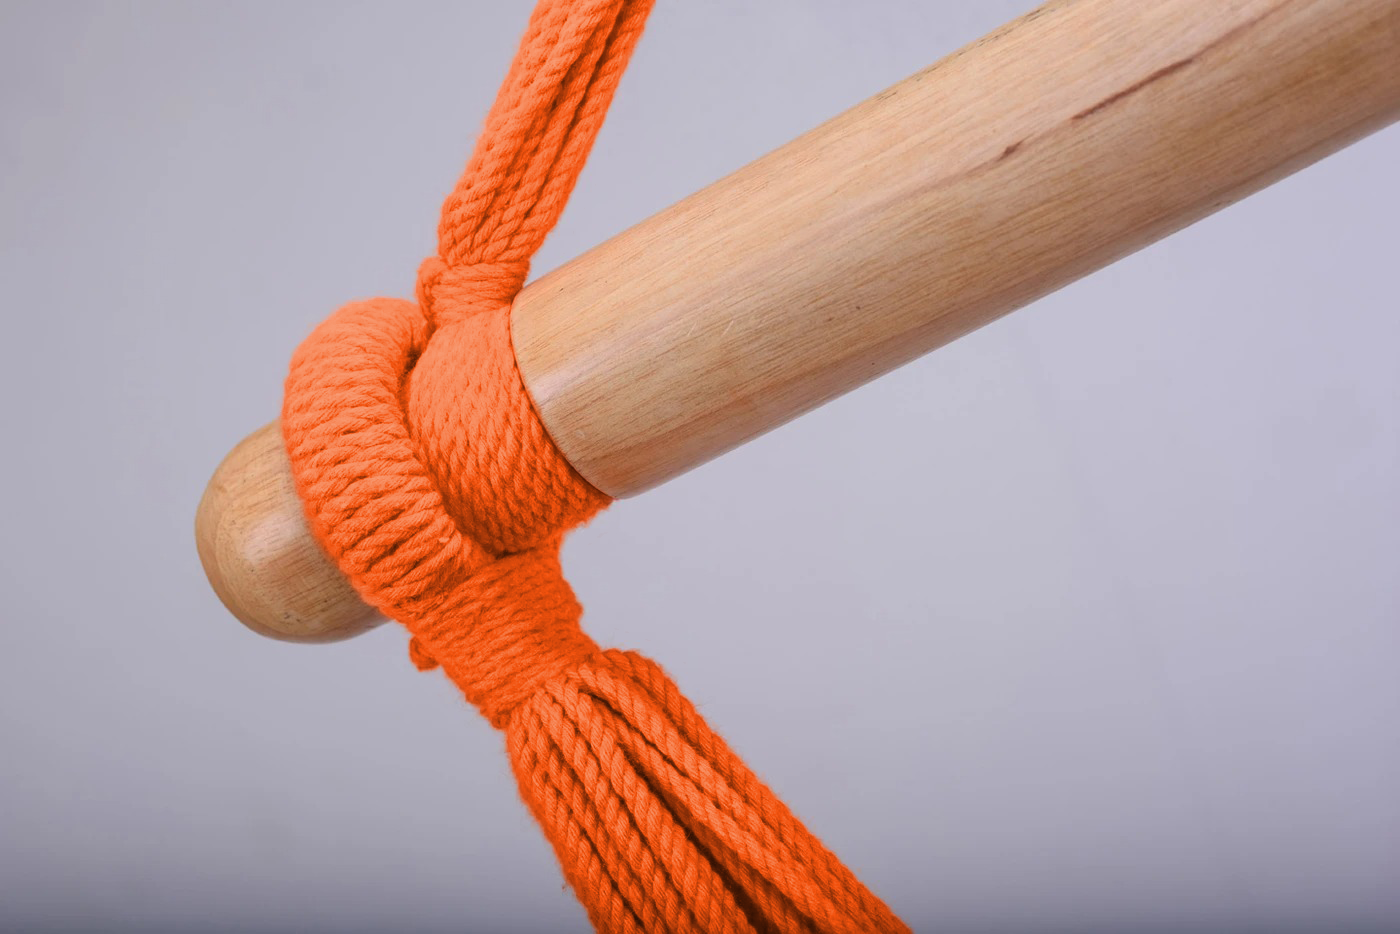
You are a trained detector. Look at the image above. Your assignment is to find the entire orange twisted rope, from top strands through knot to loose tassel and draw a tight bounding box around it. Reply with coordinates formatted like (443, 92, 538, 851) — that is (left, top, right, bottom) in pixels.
(283, 0, 907, 934)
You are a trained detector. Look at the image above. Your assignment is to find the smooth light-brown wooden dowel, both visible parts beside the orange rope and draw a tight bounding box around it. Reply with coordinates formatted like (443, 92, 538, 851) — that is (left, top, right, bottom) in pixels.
(197, 0, 1400, 640)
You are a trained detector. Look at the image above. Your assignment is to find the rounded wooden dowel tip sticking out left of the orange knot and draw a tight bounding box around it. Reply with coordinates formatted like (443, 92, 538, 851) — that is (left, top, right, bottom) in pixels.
(195, 421, 384, 643)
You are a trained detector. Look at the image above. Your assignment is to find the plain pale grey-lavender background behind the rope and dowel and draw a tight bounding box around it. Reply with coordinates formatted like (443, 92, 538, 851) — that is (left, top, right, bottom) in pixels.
(0, 0, 1400, 933)
